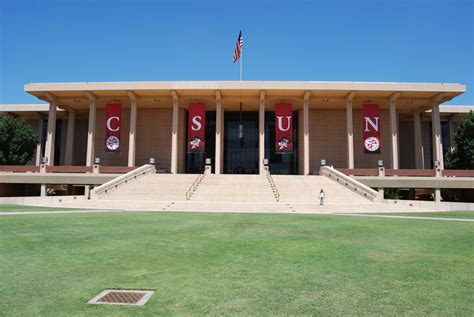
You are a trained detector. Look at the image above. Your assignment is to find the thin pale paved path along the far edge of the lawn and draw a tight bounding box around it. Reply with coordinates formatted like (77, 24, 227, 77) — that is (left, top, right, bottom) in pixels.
(0, 209, 474, 222)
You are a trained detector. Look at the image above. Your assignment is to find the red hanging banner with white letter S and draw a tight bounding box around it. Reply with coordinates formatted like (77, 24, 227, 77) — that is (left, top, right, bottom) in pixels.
(188, 102, 206, 153)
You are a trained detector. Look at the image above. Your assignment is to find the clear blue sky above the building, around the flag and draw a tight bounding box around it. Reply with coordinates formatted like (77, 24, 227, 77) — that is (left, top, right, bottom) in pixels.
(0, 0, 474, 105)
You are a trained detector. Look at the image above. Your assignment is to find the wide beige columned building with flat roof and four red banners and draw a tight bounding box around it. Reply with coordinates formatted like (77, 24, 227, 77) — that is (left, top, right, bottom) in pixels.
(0, 81, 474, 205)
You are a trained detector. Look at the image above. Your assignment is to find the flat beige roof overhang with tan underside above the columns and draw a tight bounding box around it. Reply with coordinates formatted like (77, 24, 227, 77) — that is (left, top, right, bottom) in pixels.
(25, 81, 466, 110)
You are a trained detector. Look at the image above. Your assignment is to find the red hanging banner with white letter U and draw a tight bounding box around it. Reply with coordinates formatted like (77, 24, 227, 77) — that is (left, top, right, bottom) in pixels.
(275, 103, 293, 153)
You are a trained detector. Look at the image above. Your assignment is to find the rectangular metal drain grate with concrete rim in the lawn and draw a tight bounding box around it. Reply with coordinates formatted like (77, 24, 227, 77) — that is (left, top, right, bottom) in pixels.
(88, 289, 155, 306)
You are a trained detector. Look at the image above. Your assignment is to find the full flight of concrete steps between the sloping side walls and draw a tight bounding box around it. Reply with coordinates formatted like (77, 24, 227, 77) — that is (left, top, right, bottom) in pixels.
(94, 174, 372, 204)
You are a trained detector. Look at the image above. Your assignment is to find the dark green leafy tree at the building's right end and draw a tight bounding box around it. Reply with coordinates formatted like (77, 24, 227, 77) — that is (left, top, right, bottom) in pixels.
(445, 110, 474, 169)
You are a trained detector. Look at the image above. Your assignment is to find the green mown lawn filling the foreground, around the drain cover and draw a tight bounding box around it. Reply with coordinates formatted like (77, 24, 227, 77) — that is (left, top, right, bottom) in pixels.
(0, 213, 474, 316)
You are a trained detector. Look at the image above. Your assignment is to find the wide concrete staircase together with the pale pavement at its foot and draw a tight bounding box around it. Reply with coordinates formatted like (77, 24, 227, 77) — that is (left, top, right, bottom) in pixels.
(83, 169, 416, 213)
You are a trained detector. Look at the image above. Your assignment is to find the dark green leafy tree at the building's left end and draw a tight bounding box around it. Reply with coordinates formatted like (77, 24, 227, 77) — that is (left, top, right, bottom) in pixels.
(0, 113, 38, 165)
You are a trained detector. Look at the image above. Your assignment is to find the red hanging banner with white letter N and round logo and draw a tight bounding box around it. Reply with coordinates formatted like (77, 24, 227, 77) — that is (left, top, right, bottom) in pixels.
(362, 104, 380, 153)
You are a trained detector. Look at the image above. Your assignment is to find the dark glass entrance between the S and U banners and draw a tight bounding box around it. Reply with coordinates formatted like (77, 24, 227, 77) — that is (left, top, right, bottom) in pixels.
(224, 111, 258, 174)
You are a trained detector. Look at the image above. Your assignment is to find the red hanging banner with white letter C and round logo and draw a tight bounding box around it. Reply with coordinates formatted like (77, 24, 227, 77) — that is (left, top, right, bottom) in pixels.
(105, 103, 122, 152)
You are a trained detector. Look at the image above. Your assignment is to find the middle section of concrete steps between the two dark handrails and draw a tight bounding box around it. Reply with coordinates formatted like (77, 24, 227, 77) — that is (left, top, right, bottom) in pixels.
(190, 174, 276, 203)
